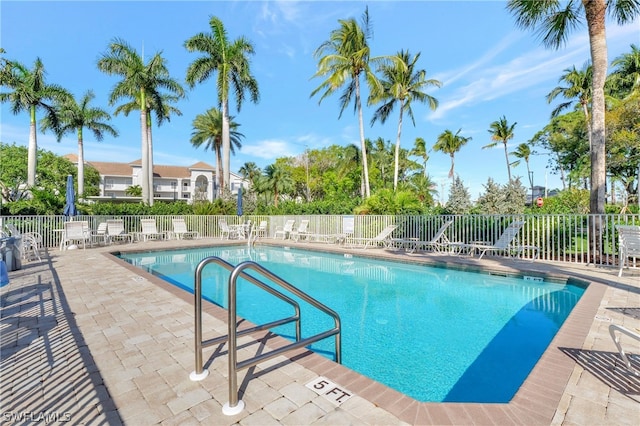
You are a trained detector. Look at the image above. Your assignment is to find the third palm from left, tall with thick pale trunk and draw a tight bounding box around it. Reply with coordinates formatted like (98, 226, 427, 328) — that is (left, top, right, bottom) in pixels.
(98, 39, 184, 205)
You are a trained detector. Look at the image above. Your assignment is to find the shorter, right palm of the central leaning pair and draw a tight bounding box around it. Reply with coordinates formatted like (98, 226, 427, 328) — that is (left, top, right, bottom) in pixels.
(370, 50, 442, 191)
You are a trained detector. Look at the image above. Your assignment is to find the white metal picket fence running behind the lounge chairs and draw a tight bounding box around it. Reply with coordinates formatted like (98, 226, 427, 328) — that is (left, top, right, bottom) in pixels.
(0, 214, 640, 265)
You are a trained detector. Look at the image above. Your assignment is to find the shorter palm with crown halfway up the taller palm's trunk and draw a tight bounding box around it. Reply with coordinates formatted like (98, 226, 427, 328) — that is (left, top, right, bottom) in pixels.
(191, 108, 244, 191)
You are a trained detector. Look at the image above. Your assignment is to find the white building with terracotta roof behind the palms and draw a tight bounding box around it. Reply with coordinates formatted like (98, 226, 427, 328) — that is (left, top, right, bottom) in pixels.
(64, 154, 249, 203)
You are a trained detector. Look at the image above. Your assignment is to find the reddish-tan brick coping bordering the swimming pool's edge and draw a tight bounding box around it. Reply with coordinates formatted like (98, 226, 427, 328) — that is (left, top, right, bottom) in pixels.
(103, 240, 606, 424)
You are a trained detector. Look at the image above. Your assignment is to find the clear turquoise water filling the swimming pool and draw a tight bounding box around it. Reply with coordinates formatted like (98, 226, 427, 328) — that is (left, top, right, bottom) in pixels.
(121, 246, 584, 403)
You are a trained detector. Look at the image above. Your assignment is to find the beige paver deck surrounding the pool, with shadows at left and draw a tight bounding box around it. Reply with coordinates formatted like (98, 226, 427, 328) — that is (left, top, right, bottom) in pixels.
(0, 240, 640, 425)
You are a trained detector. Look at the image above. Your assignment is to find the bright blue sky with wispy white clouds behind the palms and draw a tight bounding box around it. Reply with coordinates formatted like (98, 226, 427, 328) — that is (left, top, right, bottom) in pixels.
(0, 0, 640, 200)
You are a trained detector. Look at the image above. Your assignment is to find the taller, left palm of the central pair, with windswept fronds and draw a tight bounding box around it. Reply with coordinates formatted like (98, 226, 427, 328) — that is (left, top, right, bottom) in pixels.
(311, 8, 382, 198)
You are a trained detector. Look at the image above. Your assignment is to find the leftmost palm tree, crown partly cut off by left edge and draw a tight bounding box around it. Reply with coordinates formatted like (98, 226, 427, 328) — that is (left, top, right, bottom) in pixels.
(0, 58, 71, 187)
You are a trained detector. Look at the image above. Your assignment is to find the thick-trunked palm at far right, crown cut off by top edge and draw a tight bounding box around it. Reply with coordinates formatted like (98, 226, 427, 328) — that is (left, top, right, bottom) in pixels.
(507, 0, 640, 214)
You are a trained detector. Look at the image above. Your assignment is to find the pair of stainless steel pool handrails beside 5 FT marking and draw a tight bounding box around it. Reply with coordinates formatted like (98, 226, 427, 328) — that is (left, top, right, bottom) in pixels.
(189, 256, 342, 416)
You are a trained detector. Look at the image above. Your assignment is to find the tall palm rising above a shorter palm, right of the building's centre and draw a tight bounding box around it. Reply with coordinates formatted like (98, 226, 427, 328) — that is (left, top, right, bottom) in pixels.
(184, 17, 260, 188)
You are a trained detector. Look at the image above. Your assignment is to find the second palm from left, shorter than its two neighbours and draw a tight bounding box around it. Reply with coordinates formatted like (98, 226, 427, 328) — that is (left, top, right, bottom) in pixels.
(40, 90, 118, 195)
